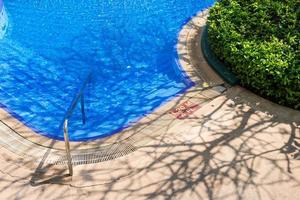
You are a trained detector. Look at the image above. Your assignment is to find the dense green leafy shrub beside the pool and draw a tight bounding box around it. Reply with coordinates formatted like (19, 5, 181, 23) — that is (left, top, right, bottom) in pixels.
(208, 0, 300, 110)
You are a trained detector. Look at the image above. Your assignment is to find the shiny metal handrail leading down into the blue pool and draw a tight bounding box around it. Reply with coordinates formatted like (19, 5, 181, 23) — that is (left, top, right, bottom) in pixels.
(63, 71, 92, 176)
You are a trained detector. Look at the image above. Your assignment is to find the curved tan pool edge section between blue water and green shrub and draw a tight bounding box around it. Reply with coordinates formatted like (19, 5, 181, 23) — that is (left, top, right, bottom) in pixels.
(176, 9, 224, 89)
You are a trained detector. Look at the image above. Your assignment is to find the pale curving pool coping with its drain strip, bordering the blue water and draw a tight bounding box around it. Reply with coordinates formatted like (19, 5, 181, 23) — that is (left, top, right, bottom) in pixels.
(0, 10, 225, 164)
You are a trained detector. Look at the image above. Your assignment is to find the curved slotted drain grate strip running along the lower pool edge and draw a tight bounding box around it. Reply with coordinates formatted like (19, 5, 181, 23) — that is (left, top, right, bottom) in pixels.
(0, 85, 226, 165)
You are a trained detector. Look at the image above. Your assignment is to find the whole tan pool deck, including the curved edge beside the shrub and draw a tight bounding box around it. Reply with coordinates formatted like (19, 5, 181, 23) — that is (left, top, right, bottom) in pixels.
(0, 11, 300, 200)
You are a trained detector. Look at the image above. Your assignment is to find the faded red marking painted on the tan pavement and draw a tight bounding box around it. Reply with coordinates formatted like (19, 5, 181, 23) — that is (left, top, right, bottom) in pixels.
(170, 101, 200, 119)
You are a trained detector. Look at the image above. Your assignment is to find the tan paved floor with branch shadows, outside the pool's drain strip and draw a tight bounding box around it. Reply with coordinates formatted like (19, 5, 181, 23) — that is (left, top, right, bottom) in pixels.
(0, 87, 300, 200)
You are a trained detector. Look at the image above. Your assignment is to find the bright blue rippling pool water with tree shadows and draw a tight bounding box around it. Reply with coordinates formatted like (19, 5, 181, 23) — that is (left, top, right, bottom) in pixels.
(0, 0, 214, 141)
